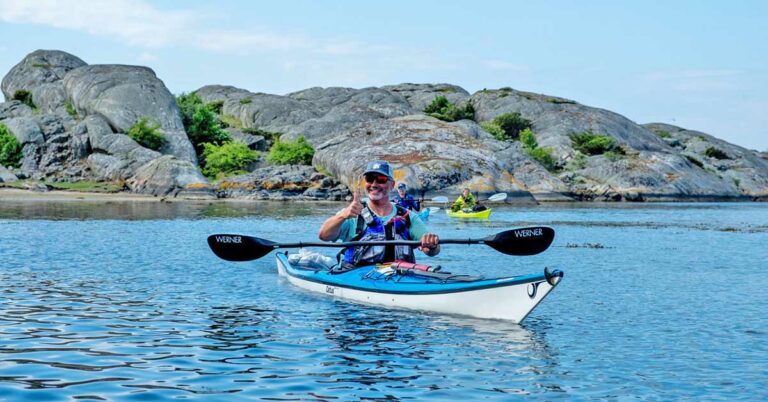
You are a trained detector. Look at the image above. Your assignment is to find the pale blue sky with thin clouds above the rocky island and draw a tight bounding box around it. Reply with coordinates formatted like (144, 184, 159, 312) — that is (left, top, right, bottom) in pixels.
(0, 0, 768, 151)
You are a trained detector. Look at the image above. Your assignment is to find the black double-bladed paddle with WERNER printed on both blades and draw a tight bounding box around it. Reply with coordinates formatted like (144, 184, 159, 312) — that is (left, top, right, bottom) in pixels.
(208, 226, 555, 261)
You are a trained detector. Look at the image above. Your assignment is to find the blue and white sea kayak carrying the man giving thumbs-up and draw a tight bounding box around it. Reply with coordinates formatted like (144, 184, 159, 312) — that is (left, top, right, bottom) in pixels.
(277, 253, 563, 323)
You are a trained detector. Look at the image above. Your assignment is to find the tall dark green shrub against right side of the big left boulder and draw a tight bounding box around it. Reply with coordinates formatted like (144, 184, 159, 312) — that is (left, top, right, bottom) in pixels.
(176, 93, 231, 156)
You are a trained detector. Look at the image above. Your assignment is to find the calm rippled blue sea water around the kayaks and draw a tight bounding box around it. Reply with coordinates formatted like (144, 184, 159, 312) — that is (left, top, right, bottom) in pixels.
(0, 202, 768, 401)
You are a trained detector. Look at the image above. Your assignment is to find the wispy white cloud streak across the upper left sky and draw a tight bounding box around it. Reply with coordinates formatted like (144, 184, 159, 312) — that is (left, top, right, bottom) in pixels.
(0, 0, 426, 58)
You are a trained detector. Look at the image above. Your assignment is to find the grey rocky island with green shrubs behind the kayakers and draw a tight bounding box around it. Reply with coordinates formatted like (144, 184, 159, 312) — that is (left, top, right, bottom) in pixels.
(0, 50, 768, 201)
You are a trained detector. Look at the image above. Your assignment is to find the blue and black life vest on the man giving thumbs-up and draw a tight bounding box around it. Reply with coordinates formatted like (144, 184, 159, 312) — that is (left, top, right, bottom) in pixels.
(342, 205, 416, 266)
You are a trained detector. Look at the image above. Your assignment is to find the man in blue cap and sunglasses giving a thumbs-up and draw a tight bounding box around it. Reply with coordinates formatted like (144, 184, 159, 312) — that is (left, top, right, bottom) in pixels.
(319, 161, 440, 267)
